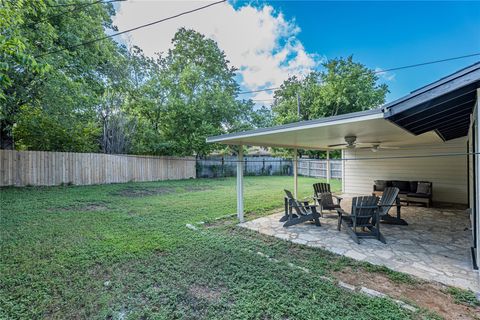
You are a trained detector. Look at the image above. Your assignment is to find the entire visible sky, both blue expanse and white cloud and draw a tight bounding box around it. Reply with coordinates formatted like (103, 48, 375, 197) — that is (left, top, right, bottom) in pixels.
(114, 0, 480, 105)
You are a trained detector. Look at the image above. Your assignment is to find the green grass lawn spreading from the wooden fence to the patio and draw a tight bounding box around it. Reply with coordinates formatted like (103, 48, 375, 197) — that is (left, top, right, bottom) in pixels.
(0, 177, 424, 319)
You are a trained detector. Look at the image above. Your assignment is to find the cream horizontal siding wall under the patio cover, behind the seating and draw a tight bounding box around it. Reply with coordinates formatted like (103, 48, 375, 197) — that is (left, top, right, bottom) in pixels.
(344, 138, 468, 204)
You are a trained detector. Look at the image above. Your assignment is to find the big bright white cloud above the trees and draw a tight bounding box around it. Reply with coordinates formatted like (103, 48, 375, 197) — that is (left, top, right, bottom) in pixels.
(114, 0, 318, 99)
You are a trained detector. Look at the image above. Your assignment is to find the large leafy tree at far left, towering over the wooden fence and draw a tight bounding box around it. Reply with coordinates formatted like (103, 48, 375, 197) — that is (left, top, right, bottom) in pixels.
(0, 0, 121, 151)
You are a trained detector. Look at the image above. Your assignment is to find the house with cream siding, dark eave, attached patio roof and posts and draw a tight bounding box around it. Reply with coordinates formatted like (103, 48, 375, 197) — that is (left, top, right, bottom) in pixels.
(207, 62, 480, 284)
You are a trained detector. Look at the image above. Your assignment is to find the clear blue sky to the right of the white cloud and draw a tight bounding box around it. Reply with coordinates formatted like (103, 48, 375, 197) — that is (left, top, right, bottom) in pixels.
(236, 1, 480, 101)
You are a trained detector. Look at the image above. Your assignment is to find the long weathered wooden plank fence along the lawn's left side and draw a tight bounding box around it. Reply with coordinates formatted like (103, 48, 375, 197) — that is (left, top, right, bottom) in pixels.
(0, 150, 195, 186)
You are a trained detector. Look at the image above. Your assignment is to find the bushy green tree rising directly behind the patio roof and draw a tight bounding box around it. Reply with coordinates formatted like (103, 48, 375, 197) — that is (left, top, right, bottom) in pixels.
(272, 56, 388, 124)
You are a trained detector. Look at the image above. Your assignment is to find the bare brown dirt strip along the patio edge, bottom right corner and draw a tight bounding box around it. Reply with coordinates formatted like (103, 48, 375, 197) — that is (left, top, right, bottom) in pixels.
(333, 268, 480, 319)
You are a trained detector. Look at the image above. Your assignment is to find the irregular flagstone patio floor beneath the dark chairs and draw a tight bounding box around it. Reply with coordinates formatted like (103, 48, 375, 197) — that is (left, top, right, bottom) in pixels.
(240, 198, 480, 292)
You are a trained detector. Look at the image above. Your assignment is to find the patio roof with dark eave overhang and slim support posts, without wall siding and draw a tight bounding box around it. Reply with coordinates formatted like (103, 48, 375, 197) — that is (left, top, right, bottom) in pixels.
(207, 62, 480, 228)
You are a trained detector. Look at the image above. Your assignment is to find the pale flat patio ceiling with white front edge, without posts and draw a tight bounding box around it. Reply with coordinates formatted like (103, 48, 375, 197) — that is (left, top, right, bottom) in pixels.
(207, 109, 442, 150)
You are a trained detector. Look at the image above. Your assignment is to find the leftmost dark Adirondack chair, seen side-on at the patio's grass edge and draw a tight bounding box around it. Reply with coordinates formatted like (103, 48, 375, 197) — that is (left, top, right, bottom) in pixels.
(280, 190, 321, 228)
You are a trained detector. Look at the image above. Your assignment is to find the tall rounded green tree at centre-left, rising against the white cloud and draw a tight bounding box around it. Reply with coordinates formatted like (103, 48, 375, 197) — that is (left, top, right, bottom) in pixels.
(151, 28, 252, 155)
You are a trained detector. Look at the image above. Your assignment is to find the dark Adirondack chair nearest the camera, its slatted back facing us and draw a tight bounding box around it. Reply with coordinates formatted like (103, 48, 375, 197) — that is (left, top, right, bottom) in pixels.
(337, 196, 386, 243)
